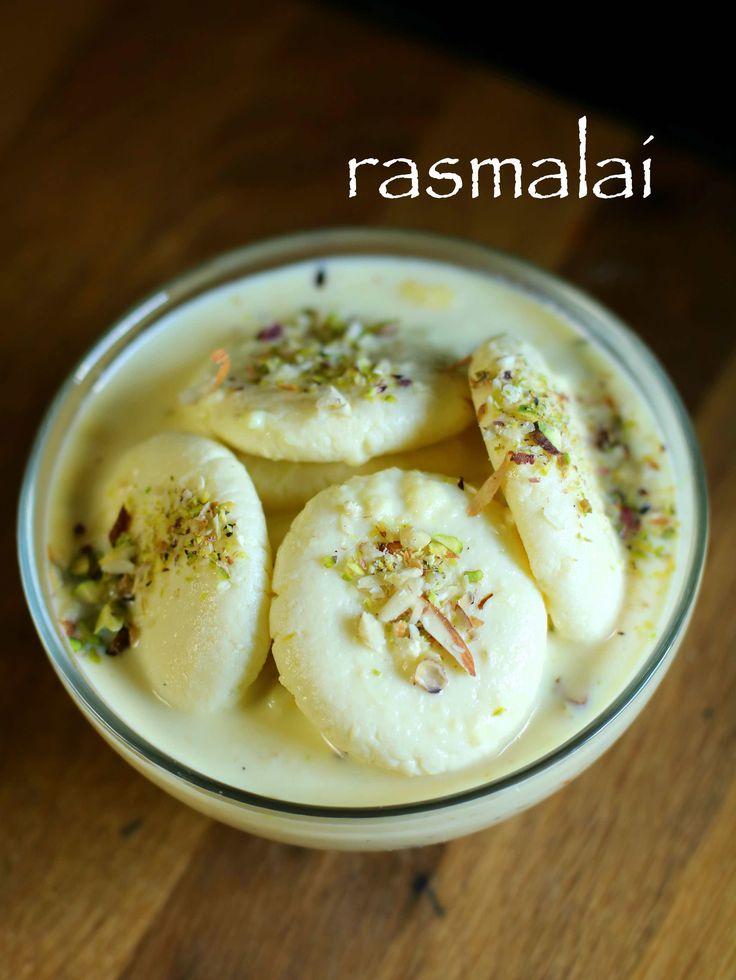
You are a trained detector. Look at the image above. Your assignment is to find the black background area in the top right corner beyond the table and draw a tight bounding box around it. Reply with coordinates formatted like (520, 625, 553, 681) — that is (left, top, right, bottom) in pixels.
(336, 0, 736, 168)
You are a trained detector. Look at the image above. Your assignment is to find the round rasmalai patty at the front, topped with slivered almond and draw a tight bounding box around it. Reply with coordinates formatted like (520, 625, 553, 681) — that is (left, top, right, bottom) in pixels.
(271, 469, 547, 774)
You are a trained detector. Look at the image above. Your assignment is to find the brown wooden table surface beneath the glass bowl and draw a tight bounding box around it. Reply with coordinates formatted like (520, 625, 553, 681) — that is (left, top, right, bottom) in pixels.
(0, 0, 736, 980)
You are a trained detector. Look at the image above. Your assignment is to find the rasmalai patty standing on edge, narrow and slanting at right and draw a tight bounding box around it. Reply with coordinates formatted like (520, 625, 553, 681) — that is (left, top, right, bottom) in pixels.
(468, 335, 624, 643)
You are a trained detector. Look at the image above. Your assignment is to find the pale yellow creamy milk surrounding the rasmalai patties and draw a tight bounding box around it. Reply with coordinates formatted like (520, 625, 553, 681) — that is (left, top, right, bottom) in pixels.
(49, 257, 677, 806)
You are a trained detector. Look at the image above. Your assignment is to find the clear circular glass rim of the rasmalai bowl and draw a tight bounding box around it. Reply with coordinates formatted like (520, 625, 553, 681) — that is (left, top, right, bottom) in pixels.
(17, 227, 708, 820)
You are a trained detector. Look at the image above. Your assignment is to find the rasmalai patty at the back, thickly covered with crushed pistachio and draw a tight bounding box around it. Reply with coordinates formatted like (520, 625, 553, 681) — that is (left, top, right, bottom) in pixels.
(190, 311, 473, 465)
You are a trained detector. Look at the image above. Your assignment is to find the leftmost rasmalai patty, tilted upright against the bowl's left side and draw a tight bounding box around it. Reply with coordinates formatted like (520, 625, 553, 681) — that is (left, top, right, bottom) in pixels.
(106, 432, 271, 711)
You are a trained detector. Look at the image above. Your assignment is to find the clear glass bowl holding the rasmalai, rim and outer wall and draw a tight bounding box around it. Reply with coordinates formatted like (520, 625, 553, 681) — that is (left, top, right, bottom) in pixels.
(18, 228, 707, 850)
